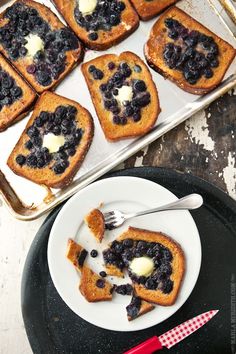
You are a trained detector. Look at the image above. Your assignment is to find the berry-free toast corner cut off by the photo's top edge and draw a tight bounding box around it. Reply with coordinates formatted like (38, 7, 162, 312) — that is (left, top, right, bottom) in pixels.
(130, 0, 178, 21)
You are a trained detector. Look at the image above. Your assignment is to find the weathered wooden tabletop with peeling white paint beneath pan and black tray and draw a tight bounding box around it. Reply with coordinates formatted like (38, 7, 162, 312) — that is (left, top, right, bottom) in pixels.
(0, 91, 236, 354)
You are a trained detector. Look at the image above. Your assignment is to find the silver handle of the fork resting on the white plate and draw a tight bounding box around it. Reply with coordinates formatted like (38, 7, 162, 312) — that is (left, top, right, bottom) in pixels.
(124, 193, 203, 219)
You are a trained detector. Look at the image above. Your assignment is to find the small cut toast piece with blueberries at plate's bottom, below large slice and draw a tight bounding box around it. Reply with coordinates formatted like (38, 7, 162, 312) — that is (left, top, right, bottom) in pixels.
(126, 295, 155, 321)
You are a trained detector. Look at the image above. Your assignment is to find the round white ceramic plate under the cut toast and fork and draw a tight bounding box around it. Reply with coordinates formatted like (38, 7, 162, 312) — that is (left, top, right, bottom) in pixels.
(48, 177, 201, 331)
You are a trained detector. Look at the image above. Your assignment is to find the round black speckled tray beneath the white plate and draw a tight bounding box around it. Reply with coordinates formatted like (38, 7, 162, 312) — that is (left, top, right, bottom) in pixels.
(21, 167, 236, 354)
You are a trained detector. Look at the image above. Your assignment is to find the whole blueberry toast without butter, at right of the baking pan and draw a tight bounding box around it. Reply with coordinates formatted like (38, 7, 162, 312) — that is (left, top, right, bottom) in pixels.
(144, 6, 236, 95)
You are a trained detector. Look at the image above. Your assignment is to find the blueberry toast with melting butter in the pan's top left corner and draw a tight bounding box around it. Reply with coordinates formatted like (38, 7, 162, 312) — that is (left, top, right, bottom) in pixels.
(0, 0, 82, 93)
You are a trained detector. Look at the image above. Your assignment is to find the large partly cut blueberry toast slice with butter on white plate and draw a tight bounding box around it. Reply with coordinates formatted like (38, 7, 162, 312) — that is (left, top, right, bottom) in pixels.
(103, 227, 185, 306)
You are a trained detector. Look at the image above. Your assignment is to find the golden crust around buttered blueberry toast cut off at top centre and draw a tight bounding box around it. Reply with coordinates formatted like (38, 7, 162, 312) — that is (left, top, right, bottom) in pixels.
(52, 0, 139, 50)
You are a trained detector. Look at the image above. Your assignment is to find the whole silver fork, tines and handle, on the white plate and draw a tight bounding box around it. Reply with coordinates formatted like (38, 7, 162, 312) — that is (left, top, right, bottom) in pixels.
(103, 193, 203, 230)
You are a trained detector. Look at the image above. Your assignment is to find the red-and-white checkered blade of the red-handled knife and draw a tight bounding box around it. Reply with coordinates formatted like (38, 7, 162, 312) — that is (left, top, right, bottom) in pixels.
(158, 310, 218, 349)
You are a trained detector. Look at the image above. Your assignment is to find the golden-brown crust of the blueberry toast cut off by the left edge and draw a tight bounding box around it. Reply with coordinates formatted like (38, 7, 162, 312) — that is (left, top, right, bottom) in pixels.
(0, 55, 36, 132)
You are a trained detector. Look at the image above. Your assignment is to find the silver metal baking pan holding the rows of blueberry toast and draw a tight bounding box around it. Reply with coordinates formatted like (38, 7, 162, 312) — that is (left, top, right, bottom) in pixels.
(0, 0, 236, 220)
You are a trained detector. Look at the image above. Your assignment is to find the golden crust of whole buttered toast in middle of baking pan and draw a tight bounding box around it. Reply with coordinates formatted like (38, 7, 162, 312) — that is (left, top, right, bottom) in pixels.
(82, 52, 161, 141)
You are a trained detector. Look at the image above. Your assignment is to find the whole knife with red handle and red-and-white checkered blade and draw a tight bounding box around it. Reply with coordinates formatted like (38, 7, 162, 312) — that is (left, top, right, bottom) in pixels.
(124, 310, 219, 354)
